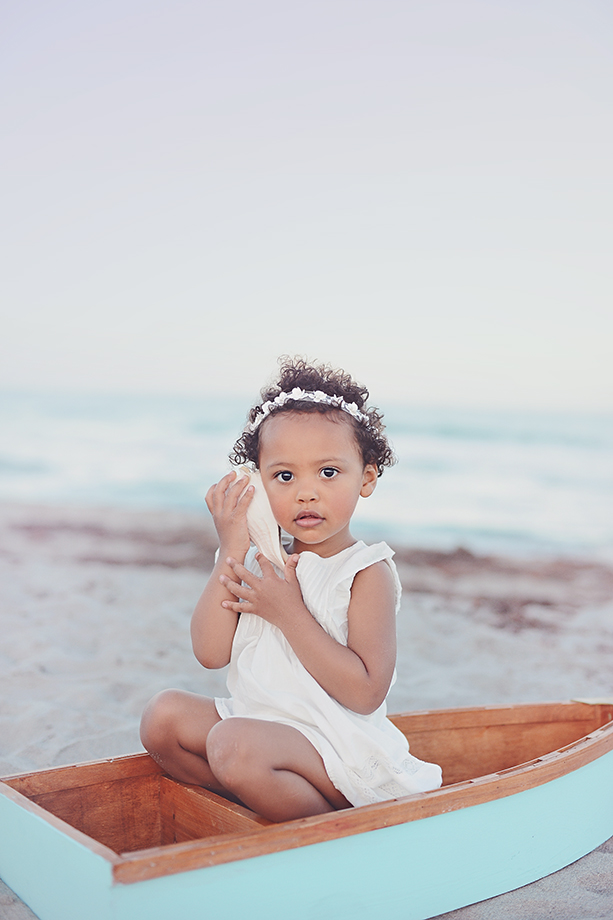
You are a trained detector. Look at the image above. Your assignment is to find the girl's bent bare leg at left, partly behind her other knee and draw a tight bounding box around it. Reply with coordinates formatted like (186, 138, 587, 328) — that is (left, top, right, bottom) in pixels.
(140, 690, 224, 792)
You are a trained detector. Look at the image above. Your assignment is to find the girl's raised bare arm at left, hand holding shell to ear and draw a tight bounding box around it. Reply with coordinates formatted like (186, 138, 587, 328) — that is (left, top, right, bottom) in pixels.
(191, 473, 253, 668)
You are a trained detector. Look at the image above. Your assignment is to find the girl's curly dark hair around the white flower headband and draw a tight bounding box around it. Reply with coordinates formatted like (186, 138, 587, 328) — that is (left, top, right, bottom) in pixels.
(230, 355, 396, 476)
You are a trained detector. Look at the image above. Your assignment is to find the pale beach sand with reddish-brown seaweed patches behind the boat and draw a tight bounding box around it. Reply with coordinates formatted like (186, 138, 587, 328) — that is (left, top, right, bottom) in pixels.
(0, 505, 613, 920)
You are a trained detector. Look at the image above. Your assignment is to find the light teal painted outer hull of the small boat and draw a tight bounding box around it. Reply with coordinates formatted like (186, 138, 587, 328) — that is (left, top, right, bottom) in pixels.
(0, 700, 613, 920)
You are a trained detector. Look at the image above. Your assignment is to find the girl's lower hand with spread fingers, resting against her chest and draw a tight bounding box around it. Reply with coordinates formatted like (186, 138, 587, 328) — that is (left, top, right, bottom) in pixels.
(219, 553, 310, 629)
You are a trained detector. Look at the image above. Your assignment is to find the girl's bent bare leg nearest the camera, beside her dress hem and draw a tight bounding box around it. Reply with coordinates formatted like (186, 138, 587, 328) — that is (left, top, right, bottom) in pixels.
(207, 718, 350, 821)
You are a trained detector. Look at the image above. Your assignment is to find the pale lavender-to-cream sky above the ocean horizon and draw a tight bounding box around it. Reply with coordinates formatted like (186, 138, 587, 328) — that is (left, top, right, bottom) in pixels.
(0, 0, 613, 409)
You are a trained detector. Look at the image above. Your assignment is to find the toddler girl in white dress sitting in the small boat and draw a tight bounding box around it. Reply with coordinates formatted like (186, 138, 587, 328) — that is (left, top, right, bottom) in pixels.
(141, 359, 441, 821)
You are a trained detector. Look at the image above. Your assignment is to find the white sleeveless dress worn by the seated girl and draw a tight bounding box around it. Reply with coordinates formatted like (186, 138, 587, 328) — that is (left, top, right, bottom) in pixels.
(215, 541, 441, 805)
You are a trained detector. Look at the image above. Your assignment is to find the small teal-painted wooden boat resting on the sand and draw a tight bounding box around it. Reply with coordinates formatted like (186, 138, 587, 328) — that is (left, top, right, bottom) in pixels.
(0, 700, 613, 920)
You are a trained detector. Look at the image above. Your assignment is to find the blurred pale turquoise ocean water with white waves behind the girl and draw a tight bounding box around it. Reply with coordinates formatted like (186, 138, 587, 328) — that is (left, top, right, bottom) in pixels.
(0, 393, 613, 560)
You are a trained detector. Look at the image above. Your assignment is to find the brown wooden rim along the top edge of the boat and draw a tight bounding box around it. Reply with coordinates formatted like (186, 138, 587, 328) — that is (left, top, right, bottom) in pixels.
(0, 700, 613, 884)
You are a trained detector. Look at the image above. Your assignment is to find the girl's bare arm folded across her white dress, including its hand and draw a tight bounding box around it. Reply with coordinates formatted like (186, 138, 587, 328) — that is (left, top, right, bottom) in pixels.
(222, 556, 396, 714)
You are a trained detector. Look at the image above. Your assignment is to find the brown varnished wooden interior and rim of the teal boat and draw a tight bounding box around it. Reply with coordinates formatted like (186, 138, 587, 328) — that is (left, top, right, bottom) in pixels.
(2, 701, 613, 882)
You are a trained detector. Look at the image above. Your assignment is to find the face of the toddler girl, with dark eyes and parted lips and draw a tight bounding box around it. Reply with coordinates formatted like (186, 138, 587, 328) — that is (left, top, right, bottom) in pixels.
(259, 412, 377, 556)
